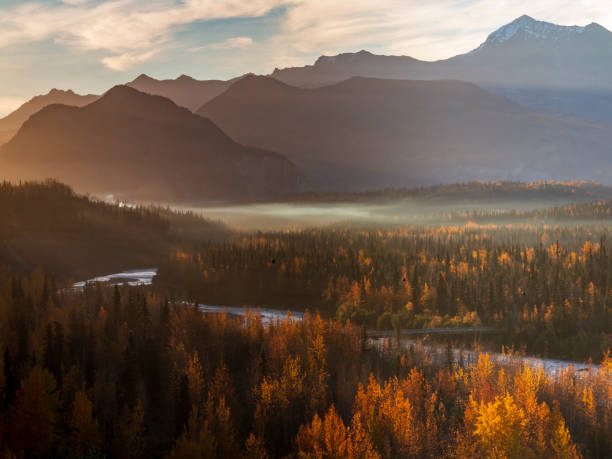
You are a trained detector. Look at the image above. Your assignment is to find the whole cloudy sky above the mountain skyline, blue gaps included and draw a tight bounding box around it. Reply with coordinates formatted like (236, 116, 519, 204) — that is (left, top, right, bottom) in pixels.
(0, 0, 612, 116)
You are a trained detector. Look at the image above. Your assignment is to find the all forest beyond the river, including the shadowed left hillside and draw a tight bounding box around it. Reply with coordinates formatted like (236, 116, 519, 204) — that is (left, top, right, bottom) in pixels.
(0, 181, 612, 361)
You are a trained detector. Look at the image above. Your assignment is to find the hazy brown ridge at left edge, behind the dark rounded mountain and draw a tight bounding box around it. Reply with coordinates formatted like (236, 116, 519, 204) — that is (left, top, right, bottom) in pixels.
(0, 89, 99, 145)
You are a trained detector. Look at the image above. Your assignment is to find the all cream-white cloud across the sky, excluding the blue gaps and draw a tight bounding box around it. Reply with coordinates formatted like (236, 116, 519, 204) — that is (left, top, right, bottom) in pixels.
(0, 0, 612, 71)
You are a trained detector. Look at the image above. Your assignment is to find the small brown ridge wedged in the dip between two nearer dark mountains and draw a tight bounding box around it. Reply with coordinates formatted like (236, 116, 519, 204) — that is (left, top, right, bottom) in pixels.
(127, 74, 240, 112)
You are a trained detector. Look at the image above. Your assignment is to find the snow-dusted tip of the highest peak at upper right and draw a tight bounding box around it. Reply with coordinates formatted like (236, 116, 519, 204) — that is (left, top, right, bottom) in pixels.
(484, 15, 589, 45)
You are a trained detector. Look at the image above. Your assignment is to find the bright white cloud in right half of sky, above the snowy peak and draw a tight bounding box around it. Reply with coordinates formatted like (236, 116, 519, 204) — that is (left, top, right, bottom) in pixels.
(278, 0, 612, 60)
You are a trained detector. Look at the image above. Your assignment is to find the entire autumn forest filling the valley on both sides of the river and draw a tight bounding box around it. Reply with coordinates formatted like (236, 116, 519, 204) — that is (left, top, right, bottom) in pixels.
(0, 182, 612, 459)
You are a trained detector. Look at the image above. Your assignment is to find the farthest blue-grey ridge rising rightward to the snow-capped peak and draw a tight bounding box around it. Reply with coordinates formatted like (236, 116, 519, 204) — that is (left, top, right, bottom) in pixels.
(271, 16, 612, 121)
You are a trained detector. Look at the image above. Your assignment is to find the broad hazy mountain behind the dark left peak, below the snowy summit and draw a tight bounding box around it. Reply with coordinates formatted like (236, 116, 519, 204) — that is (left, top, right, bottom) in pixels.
(198, 76, 612, 190)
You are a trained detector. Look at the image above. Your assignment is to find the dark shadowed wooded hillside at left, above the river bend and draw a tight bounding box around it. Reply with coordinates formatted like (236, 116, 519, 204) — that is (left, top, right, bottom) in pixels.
(0, 182, 229, 280)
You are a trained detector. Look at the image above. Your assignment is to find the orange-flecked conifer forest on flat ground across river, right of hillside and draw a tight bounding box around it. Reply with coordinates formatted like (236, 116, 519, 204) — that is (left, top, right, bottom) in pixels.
(155, 224, 612, 360)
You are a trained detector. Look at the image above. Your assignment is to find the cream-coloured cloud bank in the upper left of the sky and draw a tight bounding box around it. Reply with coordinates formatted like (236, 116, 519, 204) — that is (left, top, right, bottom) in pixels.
(0, 0, 290, 70)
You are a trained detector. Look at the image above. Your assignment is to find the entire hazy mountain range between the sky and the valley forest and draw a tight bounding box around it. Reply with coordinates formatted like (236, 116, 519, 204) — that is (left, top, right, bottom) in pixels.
(0, 16, 612, 200)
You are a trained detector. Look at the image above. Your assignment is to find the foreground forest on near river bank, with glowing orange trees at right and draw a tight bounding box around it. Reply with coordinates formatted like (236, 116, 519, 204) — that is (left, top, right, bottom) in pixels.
(0, 270, 612, 458)
